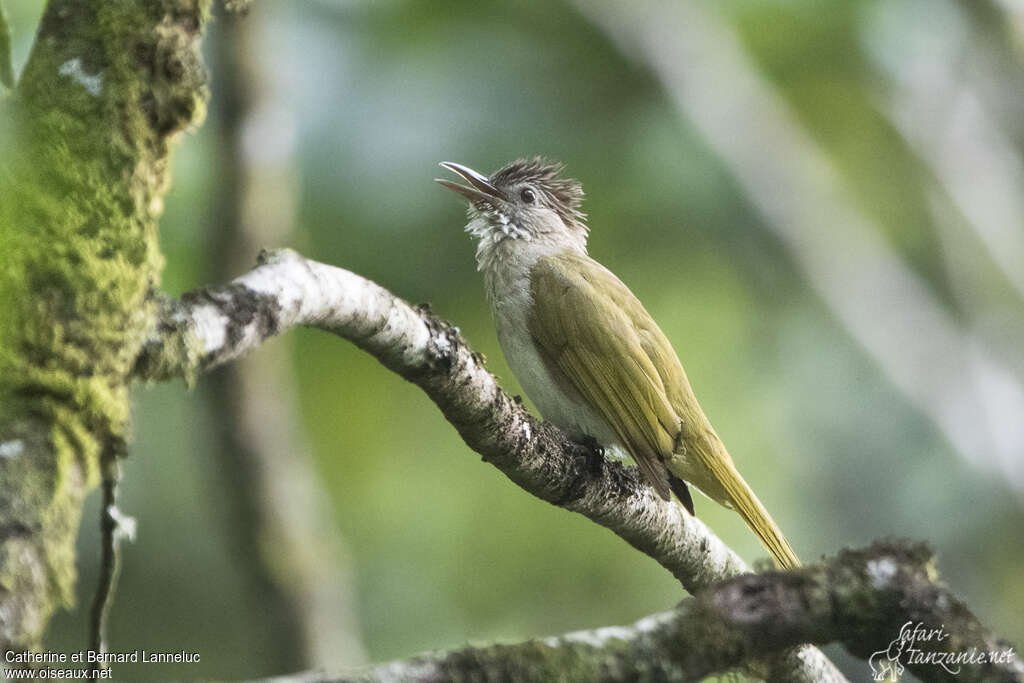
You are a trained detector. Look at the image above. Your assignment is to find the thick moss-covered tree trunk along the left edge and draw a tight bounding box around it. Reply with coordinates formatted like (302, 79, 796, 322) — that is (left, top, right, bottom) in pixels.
(0, 0, 209, 643)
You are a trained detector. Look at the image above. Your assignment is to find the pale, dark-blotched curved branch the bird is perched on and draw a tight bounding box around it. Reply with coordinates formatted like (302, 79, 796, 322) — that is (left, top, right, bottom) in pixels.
(135, 250, 843, 681)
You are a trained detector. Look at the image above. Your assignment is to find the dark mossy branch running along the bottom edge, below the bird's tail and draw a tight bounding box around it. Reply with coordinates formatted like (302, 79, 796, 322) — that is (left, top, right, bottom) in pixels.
(260, 542, 1024, 683)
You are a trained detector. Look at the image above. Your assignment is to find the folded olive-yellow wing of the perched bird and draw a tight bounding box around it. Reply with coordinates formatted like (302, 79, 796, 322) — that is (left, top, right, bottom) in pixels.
(527, 254, 682, 500)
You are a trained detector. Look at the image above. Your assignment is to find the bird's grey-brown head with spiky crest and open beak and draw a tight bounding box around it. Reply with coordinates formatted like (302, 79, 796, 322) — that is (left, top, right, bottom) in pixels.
(437, 158, 587, 248)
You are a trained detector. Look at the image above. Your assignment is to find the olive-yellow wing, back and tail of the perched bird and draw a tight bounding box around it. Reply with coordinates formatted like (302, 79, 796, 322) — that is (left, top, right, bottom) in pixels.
(527, 252, 800, 567)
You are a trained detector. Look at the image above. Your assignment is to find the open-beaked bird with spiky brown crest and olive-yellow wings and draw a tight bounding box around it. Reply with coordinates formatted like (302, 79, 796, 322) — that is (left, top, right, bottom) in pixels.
(435, 158, 800, 568)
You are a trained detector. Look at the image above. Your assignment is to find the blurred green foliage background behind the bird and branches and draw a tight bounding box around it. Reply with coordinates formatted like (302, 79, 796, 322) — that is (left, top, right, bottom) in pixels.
(7, 0, 1024, 680)
